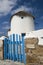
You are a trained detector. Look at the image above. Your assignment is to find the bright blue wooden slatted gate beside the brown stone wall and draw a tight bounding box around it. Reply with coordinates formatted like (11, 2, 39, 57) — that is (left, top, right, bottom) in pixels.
(4, 34, 26, 64)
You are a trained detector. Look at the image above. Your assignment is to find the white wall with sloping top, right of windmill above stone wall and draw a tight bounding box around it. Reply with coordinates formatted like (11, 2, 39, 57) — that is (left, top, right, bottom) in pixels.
(25, 29, 43, 45)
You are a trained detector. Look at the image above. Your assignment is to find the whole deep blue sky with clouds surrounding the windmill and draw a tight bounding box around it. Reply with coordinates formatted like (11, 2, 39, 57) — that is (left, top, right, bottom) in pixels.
(0, 0, 43, 36)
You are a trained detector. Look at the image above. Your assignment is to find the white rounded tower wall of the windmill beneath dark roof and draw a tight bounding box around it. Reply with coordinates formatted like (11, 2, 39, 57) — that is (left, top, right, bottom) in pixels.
(11, 15, 34, 34)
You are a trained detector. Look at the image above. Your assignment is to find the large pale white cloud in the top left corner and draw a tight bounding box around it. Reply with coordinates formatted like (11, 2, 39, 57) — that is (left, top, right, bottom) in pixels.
(0, 0, 17, 16)
